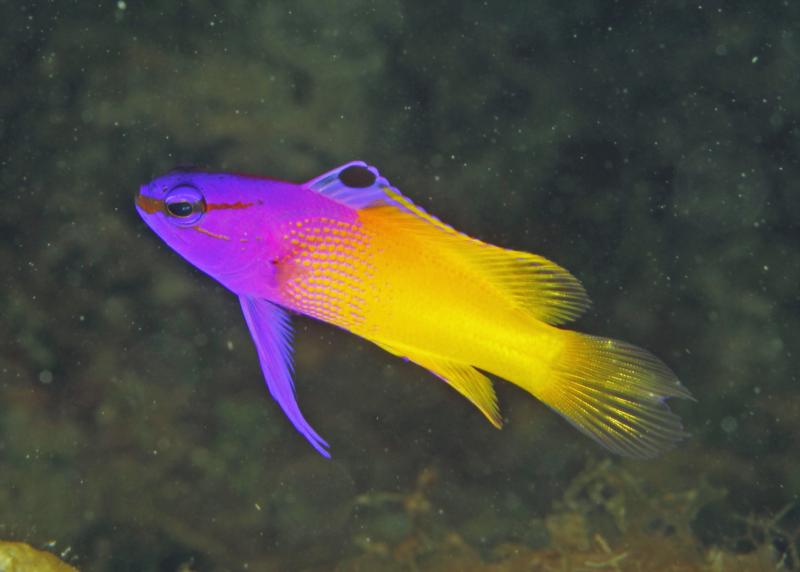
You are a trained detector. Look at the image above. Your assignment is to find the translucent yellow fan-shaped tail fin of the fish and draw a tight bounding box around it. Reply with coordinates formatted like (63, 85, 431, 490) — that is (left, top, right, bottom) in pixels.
(526, 331, 691, 458)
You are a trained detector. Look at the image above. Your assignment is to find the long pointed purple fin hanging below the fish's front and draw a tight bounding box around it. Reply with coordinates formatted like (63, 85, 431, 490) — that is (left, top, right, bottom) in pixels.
(239, 296, 330, 457)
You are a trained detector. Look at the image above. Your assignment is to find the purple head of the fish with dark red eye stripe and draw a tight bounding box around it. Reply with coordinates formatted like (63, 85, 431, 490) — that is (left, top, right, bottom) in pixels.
(136, 171, 302, 295)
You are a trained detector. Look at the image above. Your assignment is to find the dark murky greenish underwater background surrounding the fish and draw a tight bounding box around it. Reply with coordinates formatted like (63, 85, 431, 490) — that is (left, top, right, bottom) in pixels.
(0, 0, 800, 572)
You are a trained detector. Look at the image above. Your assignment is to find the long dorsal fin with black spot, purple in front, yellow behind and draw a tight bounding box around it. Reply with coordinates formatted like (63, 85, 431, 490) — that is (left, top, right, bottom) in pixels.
(305, 161, 589, 325)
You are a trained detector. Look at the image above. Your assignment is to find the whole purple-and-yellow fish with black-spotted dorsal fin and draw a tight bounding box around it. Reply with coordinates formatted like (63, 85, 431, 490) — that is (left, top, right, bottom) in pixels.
(136, 161, 690, 457)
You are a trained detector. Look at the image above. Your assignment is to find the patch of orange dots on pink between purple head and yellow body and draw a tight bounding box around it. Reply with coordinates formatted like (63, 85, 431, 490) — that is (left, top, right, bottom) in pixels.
(283, 217, 374, 330)
